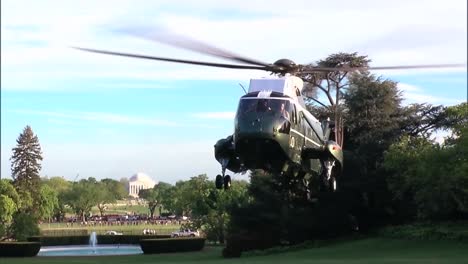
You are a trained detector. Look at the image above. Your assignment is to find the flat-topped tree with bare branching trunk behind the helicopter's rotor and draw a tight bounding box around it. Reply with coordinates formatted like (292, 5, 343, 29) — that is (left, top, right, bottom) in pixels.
(300, 53, 370, 147)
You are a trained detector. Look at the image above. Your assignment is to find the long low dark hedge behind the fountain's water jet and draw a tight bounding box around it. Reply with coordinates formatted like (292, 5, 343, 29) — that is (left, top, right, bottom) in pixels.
(28, 235, 170, 246)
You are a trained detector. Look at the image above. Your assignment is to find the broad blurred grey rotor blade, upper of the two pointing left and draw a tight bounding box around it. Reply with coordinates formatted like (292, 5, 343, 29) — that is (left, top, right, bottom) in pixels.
(120, 28, 271, 67)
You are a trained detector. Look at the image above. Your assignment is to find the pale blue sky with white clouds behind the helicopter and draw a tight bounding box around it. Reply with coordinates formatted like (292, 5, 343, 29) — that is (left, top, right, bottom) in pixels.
(0, 0, 467, 183)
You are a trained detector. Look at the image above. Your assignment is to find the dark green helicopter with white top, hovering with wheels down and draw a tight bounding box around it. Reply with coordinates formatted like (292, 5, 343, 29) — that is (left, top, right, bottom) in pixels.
(73, 32, 464, 192)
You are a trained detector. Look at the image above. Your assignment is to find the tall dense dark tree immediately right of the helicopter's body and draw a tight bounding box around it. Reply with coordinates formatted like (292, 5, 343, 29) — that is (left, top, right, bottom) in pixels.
(339, 73, 418, 229)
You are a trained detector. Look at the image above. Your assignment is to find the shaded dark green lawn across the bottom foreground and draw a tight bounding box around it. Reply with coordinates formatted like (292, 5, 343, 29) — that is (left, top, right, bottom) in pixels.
(2, 238, 468, 264)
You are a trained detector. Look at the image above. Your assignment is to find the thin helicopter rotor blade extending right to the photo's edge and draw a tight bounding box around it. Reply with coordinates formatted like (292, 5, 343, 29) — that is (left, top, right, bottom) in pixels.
(300, 64, 466, 73)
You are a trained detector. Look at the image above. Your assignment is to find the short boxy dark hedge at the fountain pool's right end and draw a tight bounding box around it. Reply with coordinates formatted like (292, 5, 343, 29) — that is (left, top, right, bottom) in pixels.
(140, 237, 206, 254)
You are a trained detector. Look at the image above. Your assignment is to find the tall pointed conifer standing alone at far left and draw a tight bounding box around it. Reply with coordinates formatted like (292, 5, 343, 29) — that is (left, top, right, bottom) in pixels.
(10, 126, 42, 212)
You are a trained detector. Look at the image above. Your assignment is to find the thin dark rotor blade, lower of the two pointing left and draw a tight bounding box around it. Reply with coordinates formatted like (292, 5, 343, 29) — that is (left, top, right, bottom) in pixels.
(72, 47, 270, 71)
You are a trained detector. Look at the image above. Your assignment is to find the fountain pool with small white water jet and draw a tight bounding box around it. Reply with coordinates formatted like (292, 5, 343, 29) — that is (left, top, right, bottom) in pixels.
(37, 232, 143, 256)
